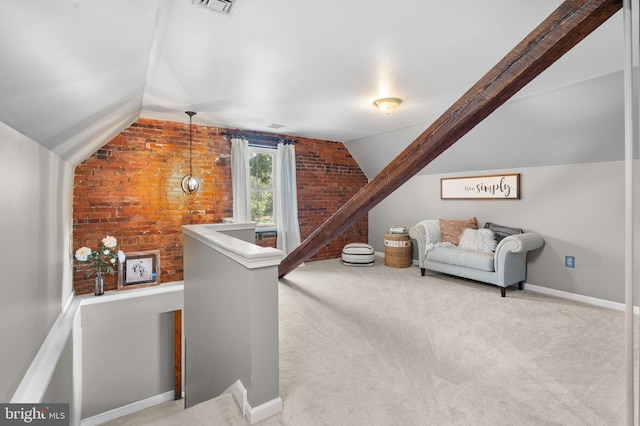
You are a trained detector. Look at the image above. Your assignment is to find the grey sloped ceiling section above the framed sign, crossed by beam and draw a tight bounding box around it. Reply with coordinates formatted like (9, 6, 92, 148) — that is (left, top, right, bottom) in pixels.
(345, 71, 624, 179)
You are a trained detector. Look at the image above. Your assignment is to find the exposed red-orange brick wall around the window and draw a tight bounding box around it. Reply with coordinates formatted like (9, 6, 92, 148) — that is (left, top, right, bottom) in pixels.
(73, 119, 368, 294)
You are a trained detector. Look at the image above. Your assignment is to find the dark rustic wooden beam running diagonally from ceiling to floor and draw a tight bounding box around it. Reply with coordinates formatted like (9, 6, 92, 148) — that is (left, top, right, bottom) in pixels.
(278, 0, 622, 278)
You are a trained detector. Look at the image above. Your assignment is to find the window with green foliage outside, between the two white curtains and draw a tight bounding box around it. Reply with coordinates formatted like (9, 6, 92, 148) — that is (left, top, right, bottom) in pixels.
(249, 146, 276, 229)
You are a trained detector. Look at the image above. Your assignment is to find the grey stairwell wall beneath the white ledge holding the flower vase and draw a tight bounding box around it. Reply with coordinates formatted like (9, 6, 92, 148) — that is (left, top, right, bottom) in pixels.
(82, 306, 182, 419)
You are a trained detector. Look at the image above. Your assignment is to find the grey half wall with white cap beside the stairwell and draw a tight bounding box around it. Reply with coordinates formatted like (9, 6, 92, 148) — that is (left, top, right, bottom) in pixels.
(183, 223, 282, 417)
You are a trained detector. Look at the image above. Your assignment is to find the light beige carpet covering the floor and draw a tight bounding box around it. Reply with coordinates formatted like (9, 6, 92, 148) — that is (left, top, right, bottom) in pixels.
(110, 257, 625, 426)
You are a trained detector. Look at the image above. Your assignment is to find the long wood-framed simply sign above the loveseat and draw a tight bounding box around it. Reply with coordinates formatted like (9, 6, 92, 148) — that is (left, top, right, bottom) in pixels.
(440, 173, 520, 200)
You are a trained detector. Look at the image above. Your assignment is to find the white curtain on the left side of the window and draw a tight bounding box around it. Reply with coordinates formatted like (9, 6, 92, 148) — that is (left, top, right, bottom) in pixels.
(231, 138, 251, 222)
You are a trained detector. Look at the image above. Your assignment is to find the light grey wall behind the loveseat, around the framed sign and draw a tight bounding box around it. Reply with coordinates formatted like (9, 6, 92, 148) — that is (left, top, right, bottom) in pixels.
(369, 161, 638, 303)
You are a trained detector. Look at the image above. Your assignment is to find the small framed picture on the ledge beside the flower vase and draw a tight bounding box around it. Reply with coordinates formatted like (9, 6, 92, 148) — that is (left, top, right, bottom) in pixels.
(118, 250, 160, 290)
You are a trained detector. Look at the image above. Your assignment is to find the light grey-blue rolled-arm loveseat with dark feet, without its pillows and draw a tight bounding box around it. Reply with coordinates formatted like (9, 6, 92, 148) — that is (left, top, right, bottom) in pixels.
(409, 219, 544, 297)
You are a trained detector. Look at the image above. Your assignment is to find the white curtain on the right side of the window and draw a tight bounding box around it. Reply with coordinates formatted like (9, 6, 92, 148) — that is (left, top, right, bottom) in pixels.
(275, 143, 300, 256)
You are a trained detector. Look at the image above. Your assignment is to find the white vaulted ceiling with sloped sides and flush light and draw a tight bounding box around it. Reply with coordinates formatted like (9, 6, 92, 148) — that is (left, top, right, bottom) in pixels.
(0, 0, 624, 173)
